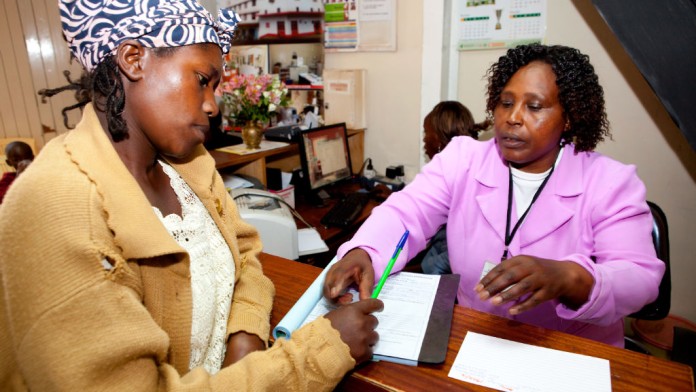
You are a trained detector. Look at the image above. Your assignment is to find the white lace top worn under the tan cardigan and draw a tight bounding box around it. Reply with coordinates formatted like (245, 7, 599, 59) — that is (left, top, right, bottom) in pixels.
(153, 161, 235, 374)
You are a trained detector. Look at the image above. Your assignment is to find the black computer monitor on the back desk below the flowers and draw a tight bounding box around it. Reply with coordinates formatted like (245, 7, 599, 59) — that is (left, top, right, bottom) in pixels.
(299, 123, 353, 202)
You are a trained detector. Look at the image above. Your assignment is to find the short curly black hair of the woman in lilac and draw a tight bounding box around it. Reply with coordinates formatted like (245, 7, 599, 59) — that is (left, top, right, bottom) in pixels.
(486, 44, 611, 153)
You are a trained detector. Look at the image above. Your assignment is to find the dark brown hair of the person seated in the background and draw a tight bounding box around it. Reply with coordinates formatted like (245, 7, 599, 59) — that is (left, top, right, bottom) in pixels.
(424, 101, 491, 147)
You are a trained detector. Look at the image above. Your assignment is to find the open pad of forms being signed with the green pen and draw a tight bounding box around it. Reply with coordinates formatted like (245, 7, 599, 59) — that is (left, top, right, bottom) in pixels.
(273, 257, 459, 366)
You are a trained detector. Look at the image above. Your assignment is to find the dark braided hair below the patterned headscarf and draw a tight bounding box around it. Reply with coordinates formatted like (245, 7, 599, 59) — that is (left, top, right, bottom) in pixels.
(38, 47, 177, 142)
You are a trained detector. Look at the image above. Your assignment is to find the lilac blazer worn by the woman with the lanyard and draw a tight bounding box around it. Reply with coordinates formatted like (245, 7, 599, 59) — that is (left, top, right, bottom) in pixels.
(338, 137, 665, 347)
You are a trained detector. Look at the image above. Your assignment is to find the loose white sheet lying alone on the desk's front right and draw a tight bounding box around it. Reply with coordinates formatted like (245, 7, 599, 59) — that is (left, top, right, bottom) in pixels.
(449, 332, 611, 392)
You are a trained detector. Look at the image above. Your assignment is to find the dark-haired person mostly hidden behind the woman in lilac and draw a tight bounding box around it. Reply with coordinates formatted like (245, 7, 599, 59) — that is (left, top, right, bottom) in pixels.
(416, 101, 491, 275)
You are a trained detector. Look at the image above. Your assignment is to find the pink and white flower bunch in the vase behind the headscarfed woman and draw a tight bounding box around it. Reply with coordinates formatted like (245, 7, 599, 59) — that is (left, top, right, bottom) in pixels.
(218, 74, 290, 125)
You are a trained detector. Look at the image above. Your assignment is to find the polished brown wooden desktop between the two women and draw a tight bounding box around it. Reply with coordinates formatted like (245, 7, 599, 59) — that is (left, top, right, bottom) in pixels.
(261, 254, 694, 391)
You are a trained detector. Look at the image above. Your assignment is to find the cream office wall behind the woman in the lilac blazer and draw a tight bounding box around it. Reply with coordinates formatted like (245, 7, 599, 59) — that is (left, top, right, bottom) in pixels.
(325, 0, 696, 321)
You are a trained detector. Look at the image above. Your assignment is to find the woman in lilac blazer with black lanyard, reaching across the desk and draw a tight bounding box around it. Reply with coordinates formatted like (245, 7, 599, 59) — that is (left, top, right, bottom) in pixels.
(324, 44, 665, 347)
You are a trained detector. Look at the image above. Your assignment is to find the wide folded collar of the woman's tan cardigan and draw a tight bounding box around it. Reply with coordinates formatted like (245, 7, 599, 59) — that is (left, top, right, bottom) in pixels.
(65, 104, 214, 259)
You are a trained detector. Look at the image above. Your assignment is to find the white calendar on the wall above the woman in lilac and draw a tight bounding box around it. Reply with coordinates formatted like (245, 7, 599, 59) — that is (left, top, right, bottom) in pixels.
(457, 0, 548, 50)
